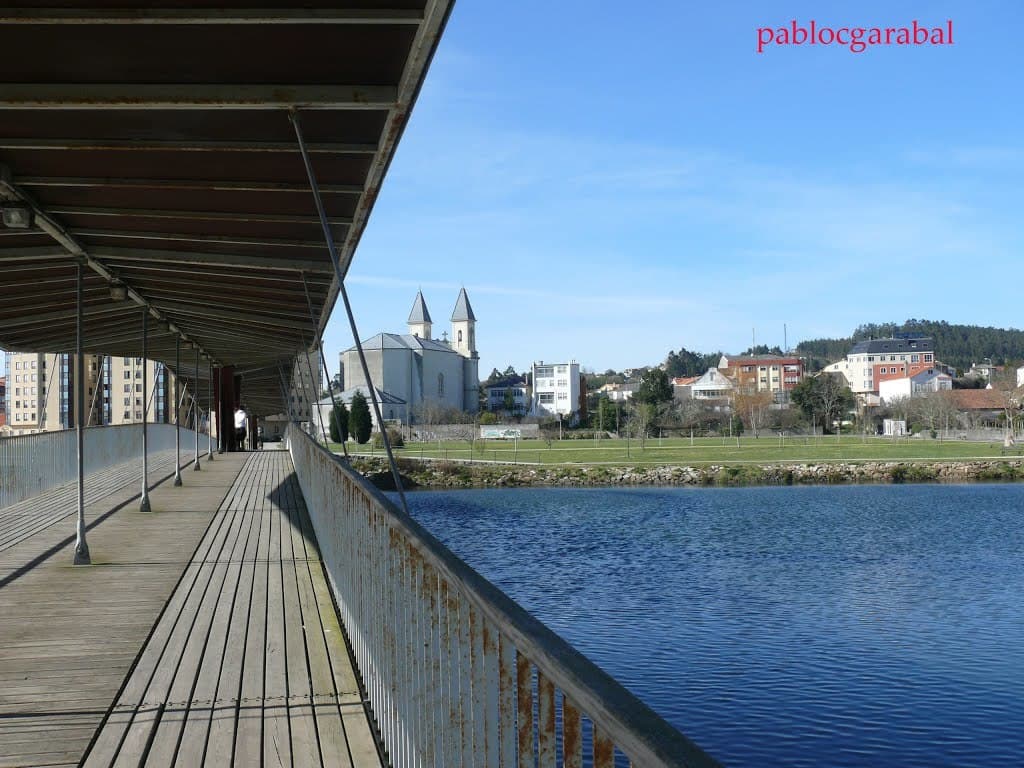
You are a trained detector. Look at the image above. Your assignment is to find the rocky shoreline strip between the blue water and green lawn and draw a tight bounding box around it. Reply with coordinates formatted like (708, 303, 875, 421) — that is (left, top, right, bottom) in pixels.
(352, 458, 1024, 489)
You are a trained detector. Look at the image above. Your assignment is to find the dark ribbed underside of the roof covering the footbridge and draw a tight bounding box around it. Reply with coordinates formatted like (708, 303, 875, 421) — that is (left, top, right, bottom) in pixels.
(0, 0, 452, 421)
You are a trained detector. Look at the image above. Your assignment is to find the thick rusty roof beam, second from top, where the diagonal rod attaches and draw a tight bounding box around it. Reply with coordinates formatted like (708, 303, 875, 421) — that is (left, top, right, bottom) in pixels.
(0, 83, 398, 110)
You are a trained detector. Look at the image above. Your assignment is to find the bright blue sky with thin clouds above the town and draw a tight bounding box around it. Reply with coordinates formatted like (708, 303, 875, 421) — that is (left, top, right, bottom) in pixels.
(327, 0, 1024, 375)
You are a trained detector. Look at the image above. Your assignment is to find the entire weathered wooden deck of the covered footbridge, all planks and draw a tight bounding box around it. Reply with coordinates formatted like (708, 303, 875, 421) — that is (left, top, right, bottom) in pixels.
(0, 452, 381, 767)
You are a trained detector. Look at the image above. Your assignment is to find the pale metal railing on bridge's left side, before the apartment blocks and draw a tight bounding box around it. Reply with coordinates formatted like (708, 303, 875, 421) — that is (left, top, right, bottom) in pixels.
(0, 424, 196, 508)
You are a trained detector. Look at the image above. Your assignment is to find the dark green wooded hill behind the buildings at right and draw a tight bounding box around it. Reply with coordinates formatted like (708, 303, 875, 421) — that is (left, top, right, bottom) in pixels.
(797, 319, 1024, 373)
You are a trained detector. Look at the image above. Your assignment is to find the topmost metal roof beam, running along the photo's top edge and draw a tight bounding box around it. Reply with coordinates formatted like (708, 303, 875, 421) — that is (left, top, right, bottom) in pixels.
(0, 8, 423, 26)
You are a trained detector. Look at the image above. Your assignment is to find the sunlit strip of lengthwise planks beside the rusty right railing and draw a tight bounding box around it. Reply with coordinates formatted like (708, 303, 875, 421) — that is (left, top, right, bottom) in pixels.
(83, 451, 381, 768)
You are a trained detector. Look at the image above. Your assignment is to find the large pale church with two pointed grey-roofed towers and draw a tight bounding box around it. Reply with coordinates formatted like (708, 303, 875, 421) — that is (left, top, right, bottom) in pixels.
(335, 288, 480, 424)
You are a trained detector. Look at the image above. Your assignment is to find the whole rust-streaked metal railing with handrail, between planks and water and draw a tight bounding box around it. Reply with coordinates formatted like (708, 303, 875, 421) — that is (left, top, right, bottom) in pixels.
(287, 426, 718, 768)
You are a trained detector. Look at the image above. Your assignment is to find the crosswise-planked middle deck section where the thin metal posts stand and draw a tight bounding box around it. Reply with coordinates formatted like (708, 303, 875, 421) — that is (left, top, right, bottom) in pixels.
(0, 454, 248, 766)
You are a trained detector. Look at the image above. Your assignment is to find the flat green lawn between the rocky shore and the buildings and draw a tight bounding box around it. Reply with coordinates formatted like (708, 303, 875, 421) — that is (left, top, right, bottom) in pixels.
(332, 435, 1020, 466)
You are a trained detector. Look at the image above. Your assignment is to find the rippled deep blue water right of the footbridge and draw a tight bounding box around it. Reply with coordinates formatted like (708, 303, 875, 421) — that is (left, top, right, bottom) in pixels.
(409, 485, 1024, 766)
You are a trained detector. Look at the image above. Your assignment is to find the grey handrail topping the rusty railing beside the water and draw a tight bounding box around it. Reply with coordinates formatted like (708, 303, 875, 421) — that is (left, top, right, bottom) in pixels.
(288, 425, 719, 768)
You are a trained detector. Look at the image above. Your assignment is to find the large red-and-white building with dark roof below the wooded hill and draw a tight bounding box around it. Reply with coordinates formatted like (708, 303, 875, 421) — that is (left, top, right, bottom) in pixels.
(824, 334, 940, 400)
